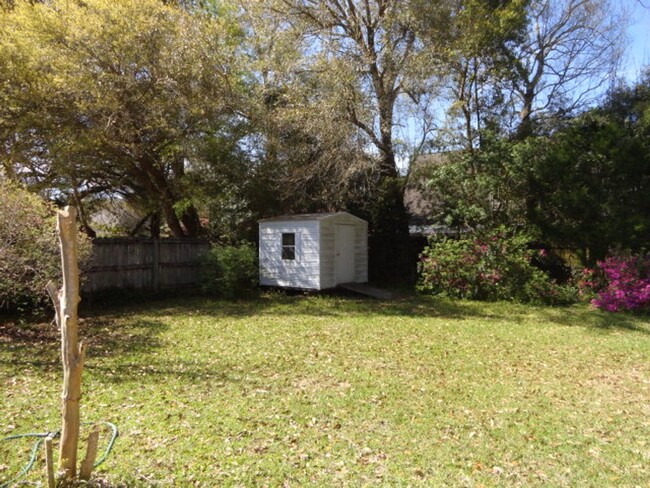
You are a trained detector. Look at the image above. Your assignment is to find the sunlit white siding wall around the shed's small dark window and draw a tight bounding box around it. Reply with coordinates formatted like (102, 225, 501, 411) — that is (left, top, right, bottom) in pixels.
(260, 220, 322, 289)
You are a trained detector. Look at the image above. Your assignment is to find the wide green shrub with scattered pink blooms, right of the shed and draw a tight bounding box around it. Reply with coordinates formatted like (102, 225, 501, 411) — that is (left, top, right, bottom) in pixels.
(418, 228, 576, 304)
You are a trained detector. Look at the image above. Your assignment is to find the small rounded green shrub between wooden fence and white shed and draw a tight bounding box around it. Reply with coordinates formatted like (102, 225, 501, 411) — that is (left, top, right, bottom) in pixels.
(201, 243, 258, 298)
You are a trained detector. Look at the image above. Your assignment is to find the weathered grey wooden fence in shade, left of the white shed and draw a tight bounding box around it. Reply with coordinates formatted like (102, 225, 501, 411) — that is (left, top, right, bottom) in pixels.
(82, 238, 210, 295)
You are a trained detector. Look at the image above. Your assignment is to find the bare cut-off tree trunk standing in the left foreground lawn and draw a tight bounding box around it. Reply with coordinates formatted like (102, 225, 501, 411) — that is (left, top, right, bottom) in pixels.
(47, 207, 85, 479)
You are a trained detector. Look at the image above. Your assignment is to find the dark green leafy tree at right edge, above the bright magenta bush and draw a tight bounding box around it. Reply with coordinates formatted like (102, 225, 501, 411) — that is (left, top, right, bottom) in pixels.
(527, 76, 650, 264)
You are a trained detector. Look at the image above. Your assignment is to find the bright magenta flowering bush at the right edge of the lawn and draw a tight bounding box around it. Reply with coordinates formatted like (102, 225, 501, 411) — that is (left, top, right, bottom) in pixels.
(580, 254, 650, 312)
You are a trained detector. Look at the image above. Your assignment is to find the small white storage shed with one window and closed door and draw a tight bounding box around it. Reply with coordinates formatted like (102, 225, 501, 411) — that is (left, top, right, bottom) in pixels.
(259, 212, 368, 290)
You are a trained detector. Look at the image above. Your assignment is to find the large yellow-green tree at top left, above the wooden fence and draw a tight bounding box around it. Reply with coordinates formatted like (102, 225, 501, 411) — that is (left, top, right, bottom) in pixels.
(0, 0, 242, 237)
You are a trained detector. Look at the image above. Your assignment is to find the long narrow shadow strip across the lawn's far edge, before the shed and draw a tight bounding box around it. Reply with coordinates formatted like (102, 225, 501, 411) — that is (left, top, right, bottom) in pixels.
(74, 290, 650, 334)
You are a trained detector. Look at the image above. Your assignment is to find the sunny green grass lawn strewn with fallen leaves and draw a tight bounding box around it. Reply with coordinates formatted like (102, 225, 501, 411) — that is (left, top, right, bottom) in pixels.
(0, 294, 650, 488)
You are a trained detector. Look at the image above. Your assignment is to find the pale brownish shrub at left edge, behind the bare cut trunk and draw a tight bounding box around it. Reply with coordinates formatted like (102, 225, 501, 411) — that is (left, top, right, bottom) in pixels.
(0, 179, 90, 311)
